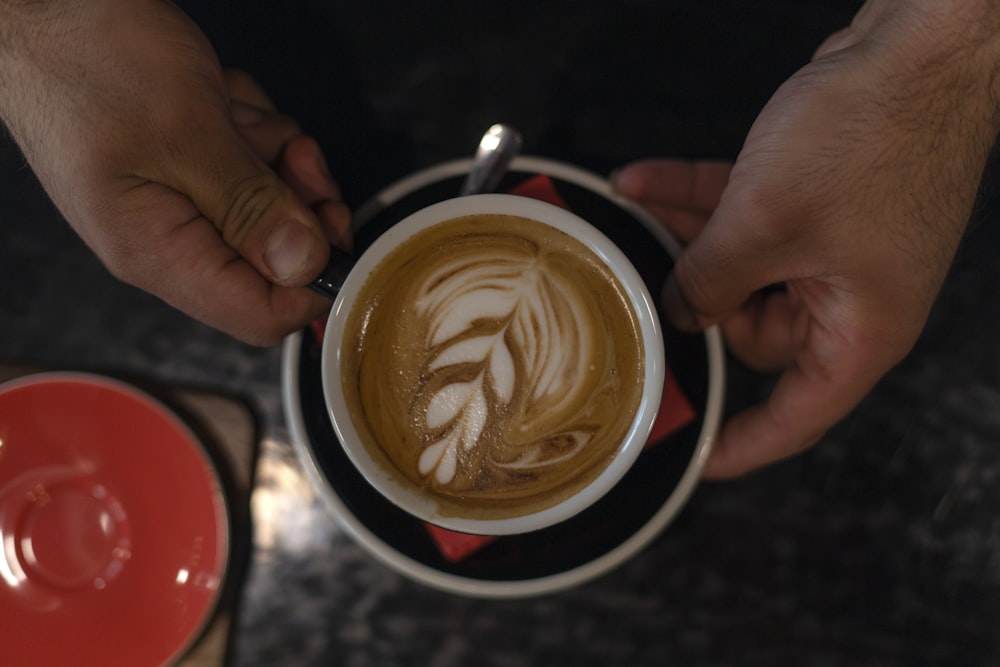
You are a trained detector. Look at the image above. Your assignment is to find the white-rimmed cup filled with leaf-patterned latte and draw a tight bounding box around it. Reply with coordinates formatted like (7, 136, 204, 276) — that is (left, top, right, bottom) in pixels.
(324, 195, 663, 534)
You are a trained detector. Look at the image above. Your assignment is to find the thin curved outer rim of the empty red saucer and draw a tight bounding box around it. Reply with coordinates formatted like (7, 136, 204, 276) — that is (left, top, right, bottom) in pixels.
(0, 370, 233, 665)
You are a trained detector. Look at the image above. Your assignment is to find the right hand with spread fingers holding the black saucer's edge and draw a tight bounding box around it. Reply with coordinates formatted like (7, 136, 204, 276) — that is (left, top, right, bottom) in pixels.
(615, 0, 1000, 478)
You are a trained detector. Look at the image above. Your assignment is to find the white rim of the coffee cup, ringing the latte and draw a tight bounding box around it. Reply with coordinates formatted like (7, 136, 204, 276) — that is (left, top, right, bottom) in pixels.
(321, 194, 665, 536)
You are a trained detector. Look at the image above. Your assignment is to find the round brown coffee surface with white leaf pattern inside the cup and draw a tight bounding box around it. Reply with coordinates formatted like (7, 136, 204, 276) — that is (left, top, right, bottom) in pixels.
(342, 215, 643, 518)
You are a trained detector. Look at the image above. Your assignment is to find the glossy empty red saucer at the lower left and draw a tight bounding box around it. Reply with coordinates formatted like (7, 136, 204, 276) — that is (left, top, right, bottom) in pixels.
(0, 373, 229, 667)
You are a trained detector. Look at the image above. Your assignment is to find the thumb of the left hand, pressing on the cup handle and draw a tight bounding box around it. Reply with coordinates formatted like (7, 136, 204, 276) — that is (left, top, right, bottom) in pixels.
(157, 113, 329, 287)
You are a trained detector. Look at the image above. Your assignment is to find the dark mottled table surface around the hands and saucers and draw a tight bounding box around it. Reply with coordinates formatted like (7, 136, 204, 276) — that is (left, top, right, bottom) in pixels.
(0, 0, 1000, 667)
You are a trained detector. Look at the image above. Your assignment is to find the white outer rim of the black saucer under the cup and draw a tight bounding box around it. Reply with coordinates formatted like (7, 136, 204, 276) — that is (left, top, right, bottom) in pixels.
(281, 156, 725, 599)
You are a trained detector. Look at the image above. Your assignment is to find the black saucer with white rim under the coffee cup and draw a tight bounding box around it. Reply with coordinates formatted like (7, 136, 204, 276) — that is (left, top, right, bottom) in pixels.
(284, 157, 724, 597)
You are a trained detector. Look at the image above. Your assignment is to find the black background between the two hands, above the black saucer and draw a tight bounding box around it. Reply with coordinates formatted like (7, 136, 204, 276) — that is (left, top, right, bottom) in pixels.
(181, 0, 860, 200)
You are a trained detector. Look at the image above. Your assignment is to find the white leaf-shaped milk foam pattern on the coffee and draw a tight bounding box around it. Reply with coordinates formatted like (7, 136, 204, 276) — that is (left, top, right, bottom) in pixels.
(416, 232, 595, 485)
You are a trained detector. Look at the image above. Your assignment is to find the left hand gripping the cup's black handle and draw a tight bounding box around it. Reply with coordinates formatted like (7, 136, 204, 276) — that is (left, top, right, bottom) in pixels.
(0, 0, 349, 345)
